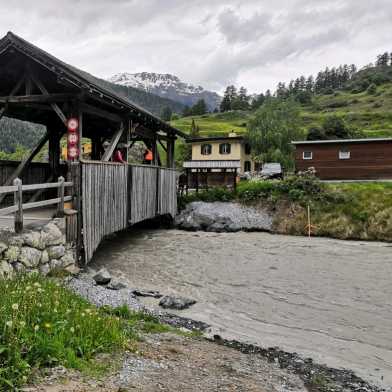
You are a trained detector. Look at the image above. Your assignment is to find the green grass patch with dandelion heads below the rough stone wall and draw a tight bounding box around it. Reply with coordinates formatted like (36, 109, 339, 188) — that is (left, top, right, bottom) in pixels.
(0, 275, 170, 390)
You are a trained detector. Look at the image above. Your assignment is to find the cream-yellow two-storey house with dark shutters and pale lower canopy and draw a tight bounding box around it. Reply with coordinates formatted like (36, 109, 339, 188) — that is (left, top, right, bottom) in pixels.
(183, 132, 255, 189)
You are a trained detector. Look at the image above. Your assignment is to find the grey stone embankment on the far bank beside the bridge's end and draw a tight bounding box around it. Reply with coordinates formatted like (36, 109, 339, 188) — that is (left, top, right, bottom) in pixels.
(175, 201, 274, 233)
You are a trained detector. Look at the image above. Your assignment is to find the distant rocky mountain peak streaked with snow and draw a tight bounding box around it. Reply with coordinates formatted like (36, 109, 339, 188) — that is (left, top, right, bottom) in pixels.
(108, 72, 221, 111)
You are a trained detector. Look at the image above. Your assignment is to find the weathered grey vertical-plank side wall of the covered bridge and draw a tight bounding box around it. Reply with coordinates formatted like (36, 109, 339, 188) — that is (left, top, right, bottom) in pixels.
(81, 161, 177, 263)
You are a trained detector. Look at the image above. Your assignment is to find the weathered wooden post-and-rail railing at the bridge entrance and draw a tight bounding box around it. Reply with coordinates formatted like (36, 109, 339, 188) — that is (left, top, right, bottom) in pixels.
(0, 177, 73, 233)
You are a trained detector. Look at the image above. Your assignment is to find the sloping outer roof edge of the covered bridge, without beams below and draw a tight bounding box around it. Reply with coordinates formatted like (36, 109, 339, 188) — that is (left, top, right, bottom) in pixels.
(0, 32, 188, 138)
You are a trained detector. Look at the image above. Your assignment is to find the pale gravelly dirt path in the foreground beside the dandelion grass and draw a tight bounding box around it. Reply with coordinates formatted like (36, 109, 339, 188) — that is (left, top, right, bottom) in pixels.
(28, 334, 307, 392)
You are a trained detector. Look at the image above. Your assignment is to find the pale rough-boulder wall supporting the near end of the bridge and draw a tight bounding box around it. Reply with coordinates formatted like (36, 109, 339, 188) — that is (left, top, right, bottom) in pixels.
(0, 219, 78, 278)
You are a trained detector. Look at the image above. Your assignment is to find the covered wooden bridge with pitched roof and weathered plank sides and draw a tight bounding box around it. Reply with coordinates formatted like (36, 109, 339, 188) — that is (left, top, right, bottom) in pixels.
(0, 33, 186, 262)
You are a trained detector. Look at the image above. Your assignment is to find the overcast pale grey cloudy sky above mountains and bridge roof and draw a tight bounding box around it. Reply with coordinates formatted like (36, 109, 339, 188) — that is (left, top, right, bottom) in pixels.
(0, 0, 392, 92)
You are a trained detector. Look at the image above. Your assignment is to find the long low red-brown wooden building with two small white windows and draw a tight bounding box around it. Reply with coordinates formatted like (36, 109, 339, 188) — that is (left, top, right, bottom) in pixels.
(293, 138, 392, 180)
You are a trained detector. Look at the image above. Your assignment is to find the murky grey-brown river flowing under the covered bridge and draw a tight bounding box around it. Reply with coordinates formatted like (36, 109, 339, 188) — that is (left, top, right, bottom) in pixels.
(91, 230, 392, 389)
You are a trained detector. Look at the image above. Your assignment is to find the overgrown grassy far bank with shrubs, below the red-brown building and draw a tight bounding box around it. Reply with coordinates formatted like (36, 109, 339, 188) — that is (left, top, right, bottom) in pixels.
(179, 176, 392, 241)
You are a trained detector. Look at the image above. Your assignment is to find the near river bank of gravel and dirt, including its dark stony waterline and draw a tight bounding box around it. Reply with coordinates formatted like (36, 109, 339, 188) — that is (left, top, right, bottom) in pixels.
(23, 269, 381, 392)
